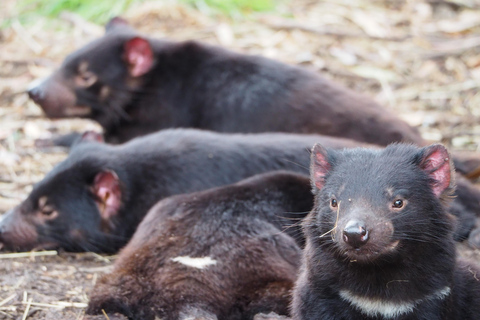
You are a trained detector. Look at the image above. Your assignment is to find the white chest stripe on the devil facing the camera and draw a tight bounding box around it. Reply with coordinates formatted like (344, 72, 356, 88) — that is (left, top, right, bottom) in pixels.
(340, 287, 450, 318)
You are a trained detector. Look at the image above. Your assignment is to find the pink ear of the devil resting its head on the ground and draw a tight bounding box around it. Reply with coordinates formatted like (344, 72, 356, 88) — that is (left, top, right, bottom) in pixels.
(93, 170, 122, 220)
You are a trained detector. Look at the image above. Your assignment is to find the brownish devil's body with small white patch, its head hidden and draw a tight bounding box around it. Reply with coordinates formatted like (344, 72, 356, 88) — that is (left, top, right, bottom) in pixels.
(86, 172, 313, 320)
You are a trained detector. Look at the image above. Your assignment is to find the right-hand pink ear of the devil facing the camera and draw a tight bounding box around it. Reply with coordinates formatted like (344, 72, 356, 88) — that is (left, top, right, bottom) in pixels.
(420, 144, 453, 197)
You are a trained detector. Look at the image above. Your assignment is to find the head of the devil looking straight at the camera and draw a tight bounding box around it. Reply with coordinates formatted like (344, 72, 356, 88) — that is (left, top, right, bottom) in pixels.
(305, 144, 454, 263)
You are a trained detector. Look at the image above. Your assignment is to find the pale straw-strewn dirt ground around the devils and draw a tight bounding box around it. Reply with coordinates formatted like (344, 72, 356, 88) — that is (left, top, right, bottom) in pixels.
(0, 0, 480, 320)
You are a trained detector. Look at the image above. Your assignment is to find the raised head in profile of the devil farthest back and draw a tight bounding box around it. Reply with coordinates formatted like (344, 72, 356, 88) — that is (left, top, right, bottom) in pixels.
(28, 18, 155, 125)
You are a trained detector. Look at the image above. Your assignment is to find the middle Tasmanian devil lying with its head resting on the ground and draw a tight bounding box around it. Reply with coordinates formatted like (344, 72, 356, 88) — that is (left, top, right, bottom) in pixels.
(0, 129, 480, 252)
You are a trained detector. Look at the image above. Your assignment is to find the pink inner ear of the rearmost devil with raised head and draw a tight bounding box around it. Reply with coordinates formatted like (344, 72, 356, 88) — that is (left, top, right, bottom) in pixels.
(124, 37, 153, 77)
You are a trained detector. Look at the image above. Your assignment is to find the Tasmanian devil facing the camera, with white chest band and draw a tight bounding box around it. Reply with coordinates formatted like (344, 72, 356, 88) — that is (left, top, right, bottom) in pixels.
(293, 144, 480, 320)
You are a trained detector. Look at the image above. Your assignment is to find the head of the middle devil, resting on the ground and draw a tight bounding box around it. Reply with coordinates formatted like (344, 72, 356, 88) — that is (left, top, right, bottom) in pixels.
(0, 146, 125, 252)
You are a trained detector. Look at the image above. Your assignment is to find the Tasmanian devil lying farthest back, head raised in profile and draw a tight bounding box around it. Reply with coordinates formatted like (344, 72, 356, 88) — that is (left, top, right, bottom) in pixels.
(29, 18, 423, 145)
